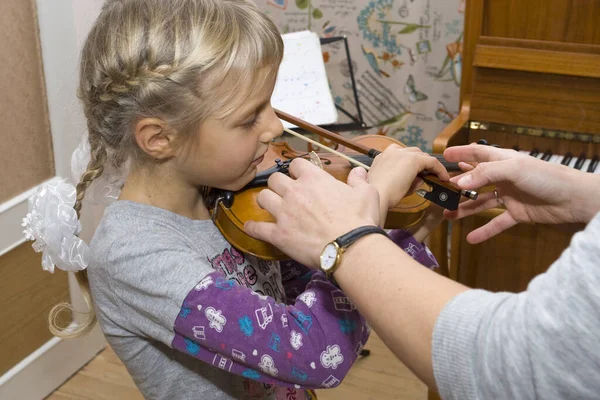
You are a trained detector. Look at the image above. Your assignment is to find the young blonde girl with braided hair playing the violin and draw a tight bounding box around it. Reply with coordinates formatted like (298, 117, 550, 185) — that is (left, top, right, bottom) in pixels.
(23, 0, 435, 400)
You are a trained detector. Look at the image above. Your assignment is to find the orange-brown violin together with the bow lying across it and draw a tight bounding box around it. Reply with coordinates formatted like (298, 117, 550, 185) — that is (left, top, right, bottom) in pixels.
(211, 110, 477, 260)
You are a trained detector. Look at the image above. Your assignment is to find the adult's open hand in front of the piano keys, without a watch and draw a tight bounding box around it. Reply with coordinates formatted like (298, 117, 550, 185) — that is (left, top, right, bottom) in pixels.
(444, 145, 600, 243)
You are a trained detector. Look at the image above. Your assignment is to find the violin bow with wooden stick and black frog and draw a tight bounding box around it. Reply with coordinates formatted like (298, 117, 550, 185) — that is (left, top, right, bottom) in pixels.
(275, 110, 478, 211)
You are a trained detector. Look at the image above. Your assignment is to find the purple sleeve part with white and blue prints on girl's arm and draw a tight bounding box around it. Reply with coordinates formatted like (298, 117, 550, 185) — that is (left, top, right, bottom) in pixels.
(172, 272, 369, 389)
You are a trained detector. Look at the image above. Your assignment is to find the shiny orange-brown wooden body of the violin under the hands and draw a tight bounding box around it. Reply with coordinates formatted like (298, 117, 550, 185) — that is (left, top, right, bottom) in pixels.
(212, 135, 430, 260)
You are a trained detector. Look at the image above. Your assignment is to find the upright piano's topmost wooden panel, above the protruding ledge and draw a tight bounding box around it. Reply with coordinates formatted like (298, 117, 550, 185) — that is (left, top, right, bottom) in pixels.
(482, 0, 600, 44)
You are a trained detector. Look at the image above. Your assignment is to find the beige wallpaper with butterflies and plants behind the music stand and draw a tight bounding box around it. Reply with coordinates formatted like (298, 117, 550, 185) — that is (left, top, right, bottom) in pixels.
(255, 0, 465, 151)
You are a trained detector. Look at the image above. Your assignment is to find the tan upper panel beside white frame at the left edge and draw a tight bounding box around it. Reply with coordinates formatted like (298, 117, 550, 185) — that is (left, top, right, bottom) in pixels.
(0, 0, 54, 203)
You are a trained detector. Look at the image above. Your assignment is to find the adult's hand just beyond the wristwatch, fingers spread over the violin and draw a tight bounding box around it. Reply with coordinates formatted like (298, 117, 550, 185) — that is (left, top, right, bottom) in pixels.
(245, 158, 380, 268)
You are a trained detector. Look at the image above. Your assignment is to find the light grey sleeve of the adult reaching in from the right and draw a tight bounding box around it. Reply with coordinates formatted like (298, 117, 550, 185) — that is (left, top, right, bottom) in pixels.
(432, 214, 600, 400)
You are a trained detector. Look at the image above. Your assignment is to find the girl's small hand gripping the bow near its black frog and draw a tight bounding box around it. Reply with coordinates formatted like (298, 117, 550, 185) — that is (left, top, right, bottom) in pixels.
(368, 144, 450, 226)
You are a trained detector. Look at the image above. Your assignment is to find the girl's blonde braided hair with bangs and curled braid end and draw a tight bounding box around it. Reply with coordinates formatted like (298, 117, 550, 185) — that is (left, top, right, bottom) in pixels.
(49, 0, 283, 338)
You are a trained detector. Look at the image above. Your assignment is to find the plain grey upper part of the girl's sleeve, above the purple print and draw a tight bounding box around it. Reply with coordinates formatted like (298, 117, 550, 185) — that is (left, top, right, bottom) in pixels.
(90, 232, 214, 346)
